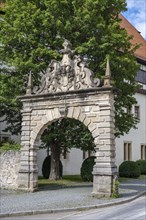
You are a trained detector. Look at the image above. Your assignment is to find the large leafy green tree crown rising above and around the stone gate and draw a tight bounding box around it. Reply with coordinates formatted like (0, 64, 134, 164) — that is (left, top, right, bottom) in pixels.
(0, 0, 138, 179)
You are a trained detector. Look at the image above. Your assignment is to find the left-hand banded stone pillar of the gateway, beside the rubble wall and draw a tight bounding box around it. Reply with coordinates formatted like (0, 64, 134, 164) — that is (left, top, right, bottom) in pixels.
(18, 109, 38, 191)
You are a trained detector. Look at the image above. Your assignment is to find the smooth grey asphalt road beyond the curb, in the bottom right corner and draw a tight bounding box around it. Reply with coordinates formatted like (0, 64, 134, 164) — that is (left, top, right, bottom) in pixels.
(2, 196, 146, 220)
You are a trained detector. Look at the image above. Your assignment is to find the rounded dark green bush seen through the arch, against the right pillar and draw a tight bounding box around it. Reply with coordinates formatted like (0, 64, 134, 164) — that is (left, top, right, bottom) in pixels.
(81, 156, 96, 182)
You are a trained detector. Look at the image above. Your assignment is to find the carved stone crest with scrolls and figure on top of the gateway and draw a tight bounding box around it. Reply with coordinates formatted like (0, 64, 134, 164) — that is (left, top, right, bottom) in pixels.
(27, 39, 100, 94)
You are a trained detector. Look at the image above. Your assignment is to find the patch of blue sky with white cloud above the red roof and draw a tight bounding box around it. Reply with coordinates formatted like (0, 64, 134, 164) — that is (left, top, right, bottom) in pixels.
(122, 0, 146, 40)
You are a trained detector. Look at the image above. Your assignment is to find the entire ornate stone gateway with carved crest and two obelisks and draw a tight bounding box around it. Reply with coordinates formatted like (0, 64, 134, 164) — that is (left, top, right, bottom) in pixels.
(18, 40, 117, 197)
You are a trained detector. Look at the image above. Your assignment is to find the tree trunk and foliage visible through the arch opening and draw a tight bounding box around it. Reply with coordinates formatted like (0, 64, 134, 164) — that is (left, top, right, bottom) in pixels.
(41, 118, 95, 180)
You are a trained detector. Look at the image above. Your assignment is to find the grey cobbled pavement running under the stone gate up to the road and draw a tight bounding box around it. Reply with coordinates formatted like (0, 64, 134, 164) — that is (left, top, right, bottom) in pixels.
(0, 179, 146, 217)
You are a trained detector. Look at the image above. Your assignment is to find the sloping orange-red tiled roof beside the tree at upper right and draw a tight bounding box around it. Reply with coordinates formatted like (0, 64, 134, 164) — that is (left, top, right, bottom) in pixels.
(119, 14, 146, 61)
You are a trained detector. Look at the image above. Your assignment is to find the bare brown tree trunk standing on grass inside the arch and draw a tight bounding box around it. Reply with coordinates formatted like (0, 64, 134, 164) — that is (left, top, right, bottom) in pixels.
(49, 144, 61, 180)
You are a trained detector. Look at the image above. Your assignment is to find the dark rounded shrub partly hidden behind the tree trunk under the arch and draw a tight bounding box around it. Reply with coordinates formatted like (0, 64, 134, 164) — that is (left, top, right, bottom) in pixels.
(42, 155, 63, 179)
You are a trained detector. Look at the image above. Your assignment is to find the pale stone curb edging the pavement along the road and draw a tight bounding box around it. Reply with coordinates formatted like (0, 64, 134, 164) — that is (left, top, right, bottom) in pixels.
(0, 190, 146, 218)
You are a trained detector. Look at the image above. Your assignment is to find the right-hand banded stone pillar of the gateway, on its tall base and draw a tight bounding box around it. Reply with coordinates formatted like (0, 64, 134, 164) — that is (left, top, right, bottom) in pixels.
(92, 92, 117, 198)
